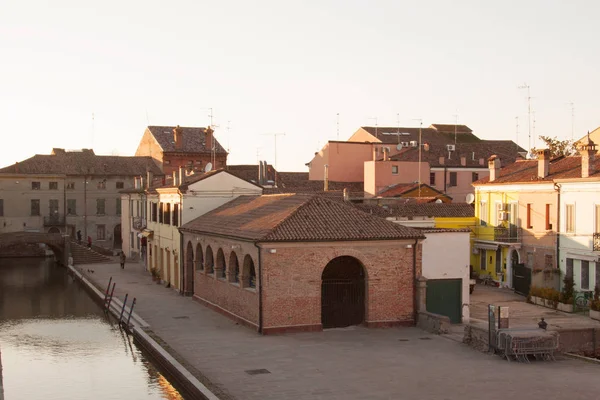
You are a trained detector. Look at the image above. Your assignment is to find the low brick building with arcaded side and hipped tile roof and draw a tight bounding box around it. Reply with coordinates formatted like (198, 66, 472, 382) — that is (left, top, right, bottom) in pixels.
(180, 194, 424, 334)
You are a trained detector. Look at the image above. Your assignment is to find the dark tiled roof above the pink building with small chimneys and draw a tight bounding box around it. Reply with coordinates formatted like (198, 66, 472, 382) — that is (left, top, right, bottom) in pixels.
(390, 140, 525, 168)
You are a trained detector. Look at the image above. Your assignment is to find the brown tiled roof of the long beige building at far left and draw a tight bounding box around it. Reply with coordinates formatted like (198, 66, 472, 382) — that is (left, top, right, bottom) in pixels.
(0, 149, 163, 176)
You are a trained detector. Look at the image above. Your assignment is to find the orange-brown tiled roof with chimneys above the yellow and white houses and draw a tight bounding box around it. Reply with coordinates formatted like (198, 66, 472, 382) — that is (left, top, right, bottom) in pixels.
(473, 156, 600, 185)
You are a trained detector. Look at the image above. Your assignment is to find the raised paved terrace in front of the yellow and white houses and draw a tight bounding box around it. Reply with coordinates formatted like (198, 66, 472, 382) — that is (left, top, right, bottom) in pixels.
(470, 285, 600, 329)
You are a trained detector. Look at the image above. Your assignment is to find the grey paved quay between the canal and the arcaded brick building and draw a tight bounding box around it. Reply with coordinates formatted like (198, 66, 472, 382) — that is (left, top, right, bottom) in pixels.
(78, 263, 600, 400)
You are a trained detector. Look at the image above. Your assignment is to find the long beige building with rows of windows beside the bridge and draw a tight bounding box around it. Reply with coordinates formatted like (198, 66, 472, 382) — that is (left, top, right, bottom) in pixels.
(0, 148, 162, 249)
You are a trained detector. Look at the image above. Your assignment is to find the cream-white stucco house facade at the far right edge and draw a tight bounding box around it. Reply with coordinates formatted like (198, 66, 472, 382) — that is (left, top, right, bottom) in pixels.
(559, 182, 600, 291)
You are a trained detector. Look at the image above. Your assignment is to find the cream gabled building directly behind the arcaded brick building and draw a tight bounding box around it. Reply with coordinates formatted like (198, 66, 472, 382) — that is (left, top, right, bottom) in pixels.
(121, 168, 262, 293)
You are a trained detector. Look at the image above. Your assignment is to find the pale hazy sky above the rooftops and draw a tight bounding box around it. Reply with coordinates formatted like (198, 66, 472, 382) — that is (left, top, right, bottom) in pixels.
(0, 0, 600, 171)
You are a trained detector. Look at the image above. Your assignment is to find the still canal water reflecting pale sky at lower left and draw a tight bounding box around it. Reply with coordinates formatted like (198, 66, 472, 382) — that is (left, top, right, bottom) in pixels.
(0, 258, 183, 400)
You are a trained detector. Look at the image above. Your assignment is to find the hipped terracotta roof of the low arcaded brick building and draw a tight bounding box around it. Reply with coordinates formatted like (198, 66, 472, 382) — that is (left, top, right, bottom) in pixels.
(181, 194, 424, 242)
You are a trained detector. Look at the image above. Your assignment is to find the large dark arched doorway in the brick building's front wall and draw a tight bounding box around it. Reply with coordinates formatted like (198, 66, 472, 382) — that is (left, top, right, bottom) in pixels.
(321, 256, 365, 329)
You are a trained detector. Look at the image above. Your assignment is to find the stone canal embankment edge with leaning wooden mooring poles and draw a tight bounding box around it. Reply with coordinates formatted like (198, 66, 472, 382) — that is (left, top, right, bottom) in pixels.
(67, 265, 220, 400)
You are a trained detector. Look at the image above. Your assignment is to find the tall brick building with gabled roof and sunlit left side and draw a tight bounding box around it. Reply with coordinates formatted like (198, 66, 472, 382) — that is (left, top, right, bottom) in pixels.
(135, 125, 227, 175)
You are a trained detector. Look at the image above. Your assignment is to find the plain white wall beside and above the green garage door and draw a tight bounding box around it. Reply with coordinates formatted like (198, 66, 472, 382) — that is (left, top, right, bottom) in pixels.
(423, 232, 470, 323)
